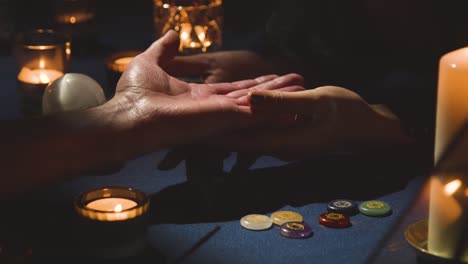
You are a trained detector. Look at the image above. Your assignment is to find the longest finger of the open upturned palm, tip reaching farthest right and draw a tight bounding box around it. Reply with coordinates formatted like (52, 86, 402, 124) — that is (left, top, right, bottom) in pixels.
(227, 73, 304, 98)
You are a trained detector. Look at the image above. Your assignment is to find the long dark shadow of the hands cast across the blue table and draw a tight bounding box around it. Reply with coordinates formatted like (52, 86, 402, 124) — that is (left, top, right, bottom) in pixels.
(150, 145, 428, 224)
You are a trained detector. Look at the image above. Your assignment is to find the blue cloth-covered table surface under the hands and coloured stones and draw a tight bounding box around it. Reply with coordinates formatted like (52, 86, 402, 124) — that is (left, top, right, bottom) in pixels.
(0, 32, 427, 263)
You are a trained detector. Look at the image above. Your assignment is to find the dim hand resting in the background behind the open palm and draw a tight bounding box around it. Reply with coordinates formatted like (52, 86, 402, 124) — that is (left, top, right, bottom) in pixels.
(164, 50, 275, 83)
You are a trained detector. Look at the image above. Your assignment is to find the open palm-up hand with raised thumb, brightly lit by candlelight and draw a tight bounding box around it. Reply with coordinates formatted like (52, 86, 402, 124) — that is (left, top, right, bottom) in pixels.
(110, 31, 303, 152)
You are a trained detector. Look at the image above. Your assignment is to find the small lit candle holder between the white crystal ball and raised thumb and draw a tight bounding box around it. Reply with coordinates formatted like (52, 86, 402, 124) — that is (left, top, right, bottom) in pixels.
(105, 50, 142, 99)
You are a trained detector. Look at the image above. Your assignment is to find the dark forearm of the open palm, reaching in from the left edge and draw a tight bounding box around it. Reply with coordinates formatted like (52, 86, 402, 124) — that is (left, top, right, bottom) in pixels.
(0, 98, 140, 198)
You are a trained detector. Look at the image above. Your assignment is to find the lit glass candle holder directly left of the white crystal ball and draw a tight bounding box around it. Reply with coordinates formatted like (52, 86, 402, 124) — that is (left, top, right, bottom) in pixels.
(15, 29, 71, 116)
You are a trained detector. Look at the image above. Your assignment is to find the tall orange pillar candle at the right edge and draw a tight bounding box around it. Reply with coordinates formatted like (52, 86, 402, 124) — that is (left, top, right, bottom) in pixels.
(428, 48, 468, 261)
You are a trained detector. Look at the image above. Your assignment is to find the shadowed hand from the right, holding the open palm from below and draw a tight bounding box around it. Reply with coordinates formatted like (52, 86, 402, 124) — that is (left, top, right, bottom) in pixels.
(207, 86, 410, 159)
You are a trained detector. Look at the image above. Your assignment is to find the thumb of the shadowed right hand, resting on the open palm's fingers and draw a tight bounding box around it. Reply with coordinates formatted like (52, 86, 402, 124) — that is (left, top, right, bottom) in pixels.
(249, 90, 316, 115)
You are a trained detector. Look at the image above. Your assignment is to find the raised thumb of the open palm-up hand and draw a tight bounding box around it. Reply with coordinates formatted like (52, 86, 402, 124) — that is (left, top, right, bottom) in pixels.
(143, 30, 179, 66)
